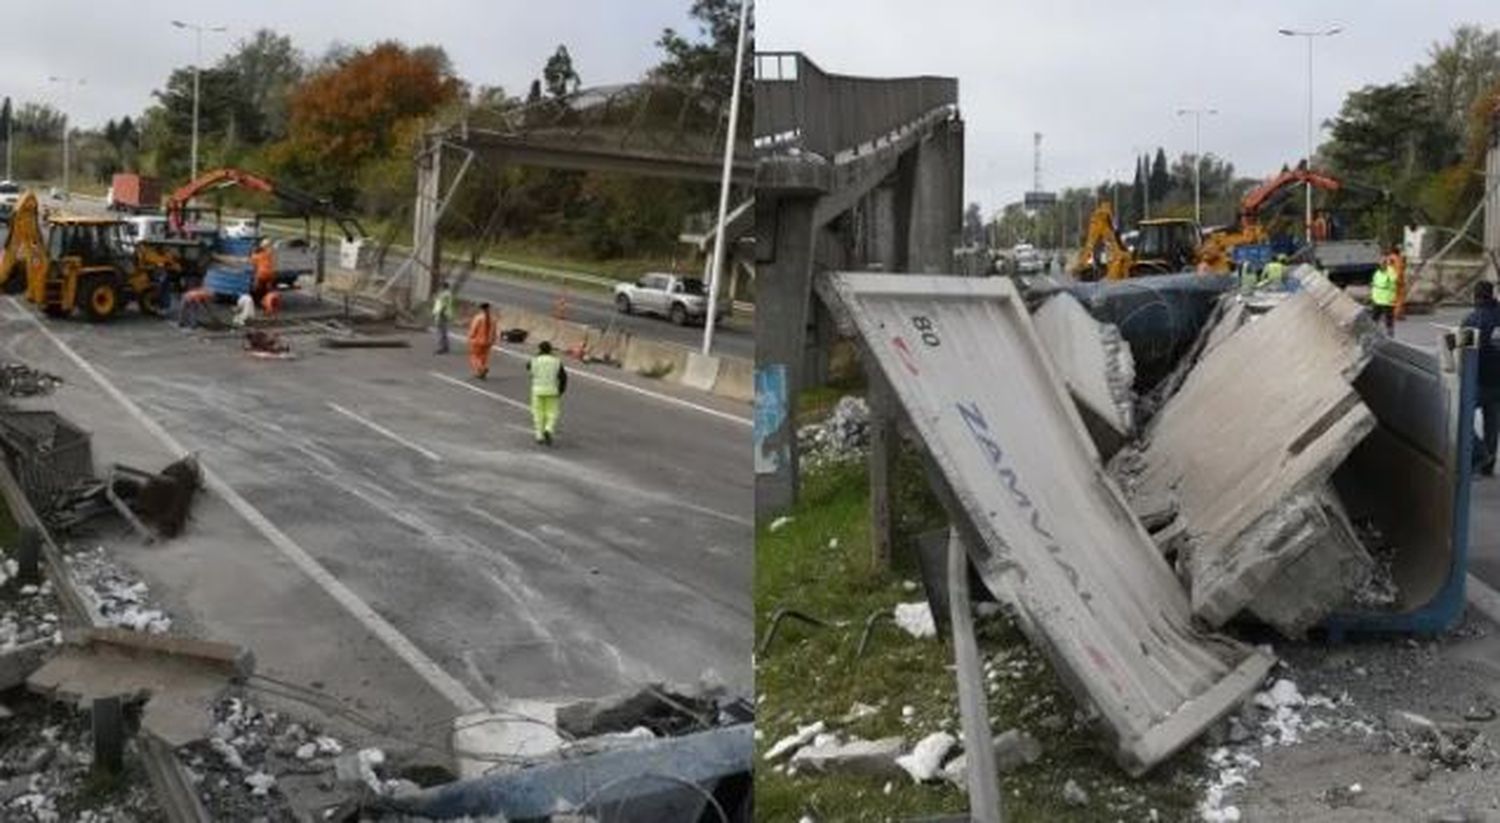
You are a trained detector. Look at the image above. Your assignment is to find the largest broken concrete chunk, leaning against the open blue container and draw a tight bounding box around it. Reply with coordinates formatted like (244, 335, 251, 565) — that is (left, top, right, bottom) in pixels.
(1128, 277, 1376, 636)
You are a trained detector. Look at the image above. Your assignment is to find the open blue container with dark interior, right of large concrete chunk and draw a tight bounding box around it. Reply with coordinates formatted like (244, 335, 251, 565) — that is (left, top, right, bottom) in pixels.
(1325, 330, 1479, 642)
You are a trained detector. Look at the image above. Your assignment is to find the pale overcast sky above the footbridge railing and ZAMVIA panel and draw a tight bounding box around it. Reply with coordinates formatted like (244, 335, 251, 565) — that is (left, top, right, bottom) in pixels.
(756, 0, 1500, 213)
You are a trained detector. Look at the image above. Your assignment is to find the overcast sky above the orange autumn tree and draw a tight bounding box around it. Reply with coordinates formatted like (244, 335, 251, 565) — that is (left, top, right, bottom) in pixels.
(0, 0, 698, 127)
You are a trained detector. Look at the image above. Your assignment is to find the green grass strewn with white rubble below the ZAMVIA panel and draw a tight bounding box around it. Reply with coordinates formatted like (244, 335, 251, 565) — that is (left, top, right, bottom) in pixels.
(755, 462, 1202, 822)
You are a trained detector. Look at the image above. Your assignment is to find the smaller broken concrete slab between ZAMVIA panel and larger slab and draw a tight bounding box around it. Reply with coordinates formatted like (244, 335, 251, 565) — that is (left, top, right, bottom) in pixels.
(1032, 294, 1136, 454)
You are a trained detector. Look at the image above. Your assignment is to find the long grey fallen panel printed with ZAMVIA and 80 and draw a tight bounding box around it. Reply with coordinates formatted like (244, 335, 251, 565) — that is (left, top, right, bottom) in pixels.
(833, 274, 1272, 775)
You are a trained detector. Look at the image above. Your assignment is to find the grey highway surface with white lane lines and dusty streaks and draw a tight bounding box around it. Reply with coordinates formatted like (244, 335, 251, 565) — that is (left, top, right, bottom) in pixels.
(0, 298, 753, 743)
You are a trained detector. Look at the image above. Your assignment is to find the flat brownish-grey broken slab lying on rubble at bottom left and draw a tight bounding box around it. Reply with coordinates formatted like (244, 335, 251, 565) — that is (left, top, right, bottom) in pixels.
(26, 628, 255, 748)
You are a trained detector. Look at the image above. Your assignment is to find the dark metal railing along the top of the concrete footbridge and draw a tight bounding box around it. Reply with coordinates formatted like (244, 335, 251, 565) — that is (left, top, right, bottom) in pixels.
(755, 51, 959, 159)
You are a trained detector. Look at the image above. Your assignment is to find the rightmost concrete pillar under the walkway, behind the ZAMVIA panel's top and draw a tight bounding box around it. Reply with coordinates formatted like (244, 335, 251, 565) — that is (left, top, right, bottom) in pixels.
(897, 120, 963, 274)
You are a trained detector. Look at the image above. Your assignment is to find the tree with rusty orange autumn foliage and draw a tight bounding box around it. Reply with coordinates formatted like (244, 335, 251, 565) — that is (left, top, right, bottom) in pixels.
(269, 42, 464, 207)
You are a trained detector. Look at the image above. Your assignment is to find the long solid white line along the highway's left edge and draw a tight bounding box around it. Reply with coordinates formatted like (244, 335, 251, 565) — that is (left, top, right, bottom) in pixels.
(11, 297, 486, 714)
